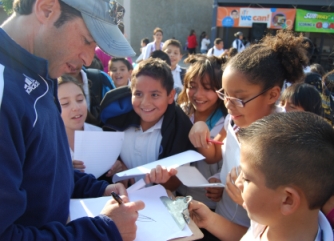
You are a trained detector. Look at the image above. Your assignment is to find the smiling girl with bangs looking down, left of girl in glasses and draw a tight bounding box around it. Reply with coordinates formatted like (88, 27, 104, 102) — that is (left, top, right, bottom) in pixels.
(178, 55, 227, 210)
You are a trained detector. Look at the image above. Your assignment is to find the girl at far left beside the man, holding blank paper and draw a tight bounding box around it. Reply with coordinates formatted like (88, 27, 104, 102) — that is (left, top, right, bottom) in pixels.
(58, 75, 123, 176)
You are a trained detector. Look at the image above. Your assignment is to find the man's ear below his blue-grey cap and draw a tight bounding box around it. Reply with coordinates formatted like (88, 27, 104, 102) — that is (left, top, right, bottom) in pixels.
(33, 0, 60, 23)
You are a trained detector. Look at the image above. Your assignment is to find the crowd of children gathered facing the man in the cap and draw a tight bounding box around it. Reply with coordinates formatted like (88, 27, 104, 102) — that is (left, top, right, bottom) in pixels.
(58, 28, 334, 241)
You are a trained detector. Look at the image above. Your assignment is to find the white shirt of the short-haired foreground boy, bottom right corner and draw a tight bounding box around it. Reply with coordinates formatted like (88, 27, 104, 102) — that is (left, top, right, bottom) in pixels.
(240, 212, 334, 241)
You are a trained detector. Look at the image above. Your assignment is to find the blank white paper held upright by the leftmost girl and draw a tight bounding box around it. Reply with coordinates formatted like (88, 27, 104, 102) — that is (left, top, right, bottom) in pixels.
(74, 131, 124, 178)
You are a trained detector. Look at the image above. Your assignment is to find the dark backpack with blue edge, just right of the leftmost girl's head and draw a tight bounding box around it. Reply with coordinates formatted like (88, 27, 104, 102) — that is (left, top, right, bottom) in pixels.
(83, 68, 115, 120)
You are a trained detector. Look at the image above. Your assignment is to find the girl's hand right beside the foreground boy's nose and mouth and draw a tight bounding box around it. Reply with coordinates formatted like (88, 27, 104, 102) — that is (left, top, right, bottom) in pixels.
(225, 167, 244, 206)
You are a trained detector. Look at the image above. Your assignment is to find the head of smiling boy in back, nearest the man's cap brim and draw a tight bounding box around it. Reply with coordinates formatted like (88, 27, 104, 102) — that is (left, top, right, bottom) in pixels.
(108, 57, 133, 88)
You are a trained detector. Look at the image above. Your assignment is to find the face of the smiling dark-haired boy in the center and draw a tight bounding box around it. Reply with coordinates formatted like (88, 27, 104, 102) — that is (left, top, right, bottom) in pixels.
(132, 75, 175, 131)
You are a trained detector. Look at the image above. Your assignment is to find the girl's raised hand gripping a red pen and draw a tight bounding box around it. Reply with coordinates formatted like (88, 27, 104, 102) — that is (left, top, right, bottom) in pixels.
(189, 121, 212, 148)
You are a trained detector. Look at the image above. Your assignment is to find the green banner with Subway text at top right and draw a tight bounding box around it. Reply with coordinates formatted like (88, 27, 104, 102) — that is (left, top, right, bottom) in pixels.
(295, 9, 334, 33)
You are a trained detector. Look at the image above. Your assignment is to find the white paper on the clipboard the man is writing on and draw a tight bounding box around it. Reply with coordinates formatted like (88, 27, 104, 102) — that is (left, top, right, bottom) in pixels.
(70, 185, 192, 241)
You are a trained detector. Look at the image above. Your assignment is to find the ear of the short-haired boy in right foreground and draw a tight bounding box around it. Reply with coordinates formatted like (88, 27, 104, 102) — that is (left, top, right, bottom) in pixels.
(281, 187, 302, 216)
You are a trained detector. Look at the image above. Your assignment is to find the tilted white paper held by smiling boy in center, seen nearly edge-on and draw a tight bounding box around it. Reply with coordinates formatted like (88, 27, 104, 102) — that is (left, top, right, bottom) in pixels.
(113, 150, 205, 183)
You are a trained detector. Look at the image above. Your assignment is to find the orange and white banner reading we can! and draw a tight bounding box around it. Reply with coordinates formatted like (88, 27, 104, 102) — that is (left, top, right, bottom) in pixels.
(217, 7, 296, 29)
